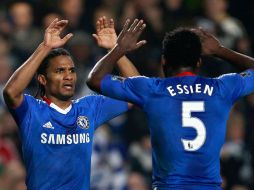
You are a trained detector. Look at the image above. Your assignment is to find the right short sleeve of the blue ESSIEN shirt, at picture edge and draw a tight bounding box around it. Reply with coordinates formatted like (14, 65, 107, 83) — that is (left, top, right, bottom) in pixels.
(219, 70, 254, 102)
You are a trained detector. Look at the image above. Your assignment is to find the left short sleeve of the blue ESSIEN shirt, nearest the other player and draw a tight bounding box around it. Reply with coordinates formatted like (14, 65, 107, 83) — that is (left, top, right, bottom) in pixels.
(101, 75, 152, 107)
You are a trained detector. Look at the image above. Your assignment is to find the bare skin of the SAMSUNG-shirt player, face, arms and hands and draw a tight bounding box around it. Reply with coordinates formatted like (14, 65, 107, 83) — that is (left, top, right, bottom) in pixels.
(3, 17, 139, 109)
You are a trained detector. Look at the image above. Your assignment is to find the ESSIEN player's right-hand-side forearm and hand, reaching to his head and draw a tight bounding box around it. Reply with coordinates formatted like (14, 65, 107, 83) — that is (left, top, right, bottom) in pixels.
(194, 29, 254, 70)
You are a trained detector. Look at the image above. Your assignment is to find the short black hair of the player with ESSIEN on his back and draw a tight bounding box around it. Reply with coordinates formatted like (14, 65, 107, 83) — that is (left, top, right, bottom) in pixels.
(162, 28, 202, 69)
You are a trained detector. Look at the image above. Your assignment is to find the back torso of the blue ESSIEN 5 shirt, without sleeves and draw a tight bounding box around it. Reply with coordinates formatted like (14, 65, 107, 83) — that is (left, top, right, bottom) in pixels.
(147, 76, 244, 189)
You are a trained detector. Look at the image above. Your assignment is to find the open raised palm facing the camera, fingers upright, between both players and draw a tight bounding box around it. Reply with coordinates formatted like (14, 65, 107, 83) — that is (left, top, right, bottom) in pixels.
(93, 16, 117, 49)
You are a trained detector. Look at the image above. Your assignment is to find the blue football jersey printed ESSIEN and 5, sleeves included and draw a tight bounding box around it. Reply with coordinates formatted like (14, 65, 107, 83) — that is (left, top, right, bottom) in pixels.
(101, 70, 254, 190)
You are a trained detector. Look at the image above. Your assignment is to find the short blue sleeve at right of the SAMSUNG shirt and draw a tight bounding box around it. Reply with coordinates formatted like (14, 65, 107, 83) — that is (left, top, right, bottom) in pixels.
(95, 95, 128, 129)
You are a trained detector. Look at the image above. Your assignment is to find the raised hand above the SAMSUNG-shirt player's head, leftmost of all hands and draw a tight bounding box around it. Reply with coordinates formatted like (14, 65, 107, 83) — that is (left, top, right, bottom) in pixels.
(43, 18, 73, 48)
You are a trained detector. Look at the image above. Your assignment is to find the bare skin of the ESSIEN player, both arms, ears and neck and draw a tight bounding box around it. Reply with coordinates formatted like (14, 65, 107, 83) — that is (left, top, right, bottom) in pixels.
(87, 19, 254, 93)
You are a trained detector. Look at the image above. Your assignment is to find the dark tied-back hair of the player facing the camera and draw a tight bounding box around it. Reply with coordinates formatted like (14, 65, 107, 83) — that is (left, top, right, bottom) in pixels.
(35, 48, 71, 98)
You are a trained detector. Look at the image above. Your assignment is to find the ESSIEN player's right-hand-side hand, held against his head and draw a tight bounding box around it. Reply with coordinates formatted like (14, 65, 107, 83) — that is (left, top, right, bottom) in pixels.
(193, 28, 222, 55)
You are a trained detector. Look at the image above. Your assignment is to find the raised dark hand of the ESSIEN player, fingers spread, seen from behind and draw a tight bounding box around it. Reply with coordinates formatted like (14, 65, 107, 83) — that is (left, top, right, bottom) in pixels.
(117, 19, 146, 52)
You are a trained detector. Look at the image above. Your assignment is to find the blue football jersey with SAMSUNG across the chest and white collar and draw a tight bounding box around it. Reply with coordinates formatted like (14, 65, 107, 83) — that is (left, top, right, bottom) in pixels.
(10, 95, 128, 190)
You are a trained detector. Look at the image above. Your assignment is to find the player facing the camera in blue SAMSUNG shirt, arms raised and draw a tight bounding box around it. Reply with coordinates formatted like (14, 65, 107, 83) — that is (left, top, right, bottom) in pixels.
(3, 17, 143, 190)
